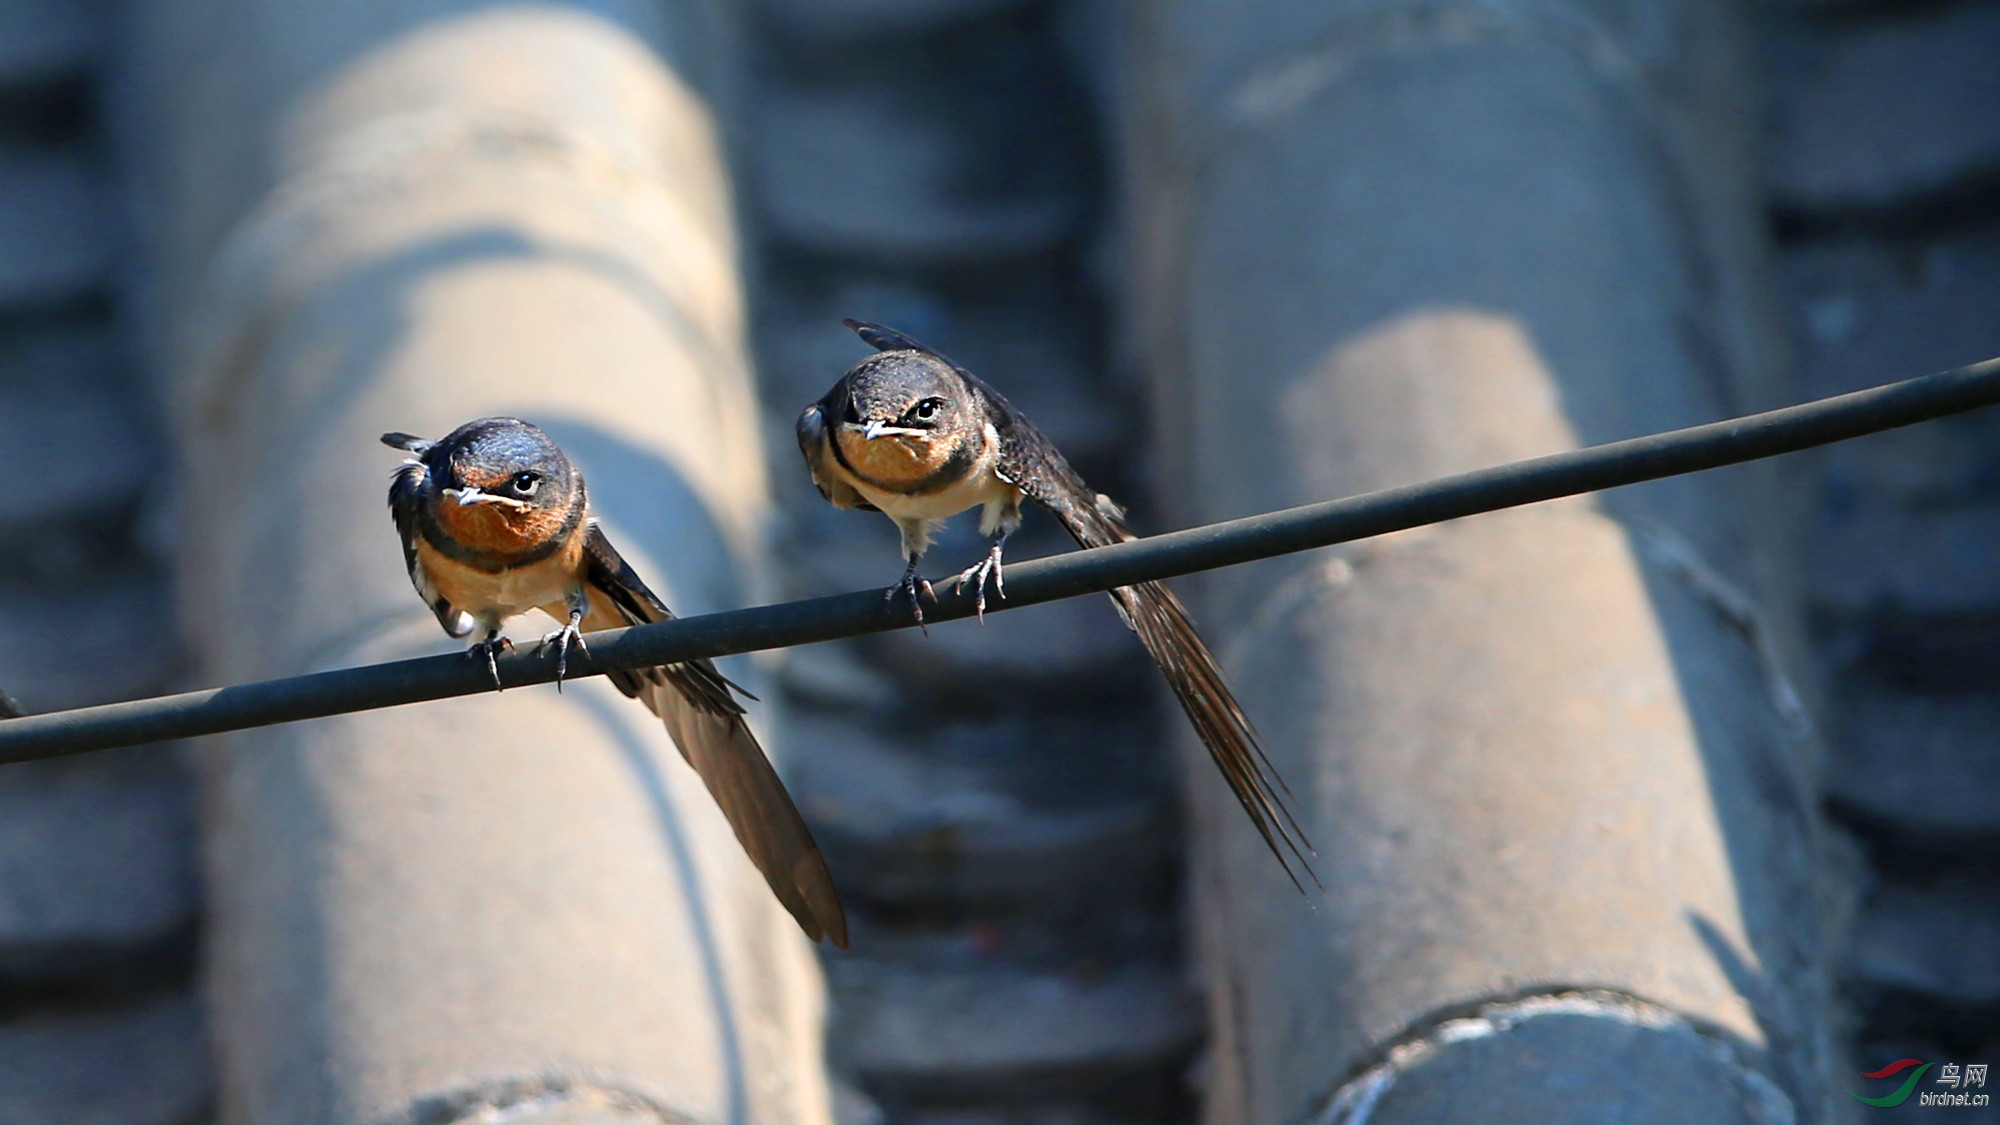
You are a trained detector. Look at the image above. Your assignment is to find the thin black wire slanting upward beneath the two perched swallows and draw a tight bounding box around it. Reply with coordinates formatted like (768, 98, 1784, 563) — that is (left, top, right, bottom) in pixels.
(0, 360, 2000, 763)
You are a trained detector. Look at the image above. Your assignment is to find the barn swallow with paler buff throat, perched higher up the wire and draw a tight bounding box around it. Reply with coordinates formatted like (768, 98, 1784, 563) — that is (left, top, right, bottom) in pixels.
(798, 320, 1318, 891)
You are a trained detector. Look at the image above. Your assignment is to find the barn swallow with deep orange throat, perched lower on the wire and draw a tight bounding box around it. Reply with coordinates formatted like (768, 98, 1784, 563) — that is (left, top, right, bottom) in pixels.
(382, 418, 848, 949)
